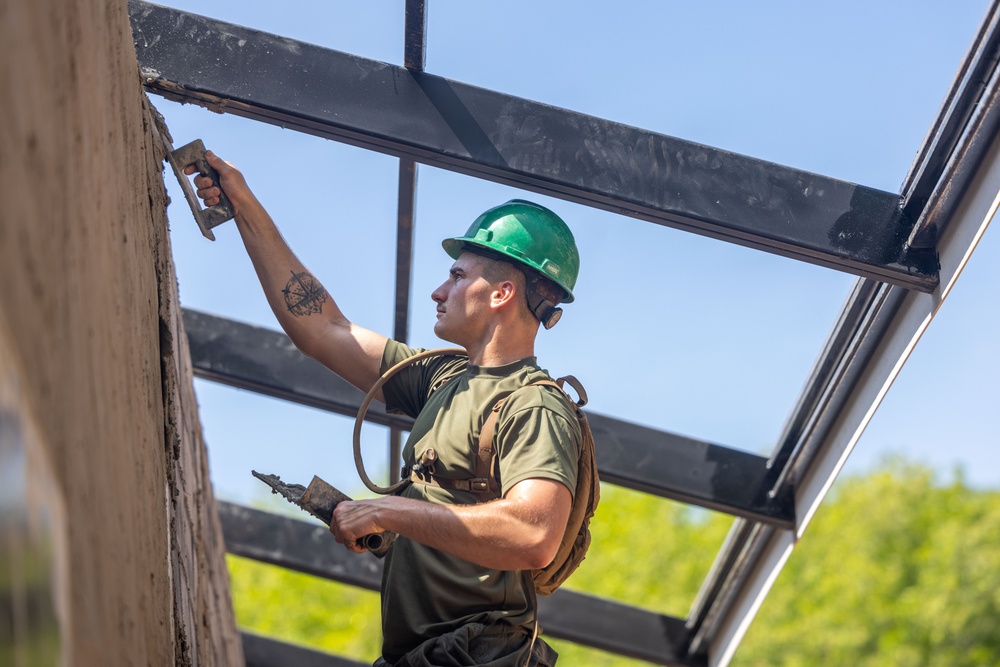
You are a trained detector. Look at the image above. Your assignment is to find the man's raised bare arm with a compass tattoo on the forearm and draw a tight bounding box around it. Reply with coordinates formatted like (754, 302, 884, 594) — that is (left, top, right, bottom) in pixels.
(189, 151, 386, 399)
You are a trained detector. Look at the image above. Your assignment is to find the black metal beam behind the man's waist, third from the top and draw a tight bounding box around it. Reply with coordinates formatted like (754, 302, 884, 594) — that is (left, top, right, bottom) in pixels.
(219, 502, 705, 667)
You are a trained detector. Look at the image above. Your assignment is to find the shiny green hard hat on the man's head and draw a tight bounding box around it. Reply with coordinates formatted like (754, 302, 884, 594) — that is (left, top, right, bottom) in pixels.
(441, 199, 580, 303)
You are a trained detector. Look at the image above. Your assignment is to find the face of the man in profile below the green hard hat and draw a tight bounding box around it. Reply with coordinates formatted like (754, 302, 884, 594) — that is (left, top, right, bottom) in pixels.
(431, 252, 493, 346)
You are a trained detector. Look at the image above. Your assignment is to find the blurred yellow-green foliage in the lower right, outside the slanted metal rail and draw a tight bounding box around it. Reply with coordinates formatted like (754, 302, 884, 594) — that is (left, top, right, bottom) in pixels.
(733, 463, 1000, 667)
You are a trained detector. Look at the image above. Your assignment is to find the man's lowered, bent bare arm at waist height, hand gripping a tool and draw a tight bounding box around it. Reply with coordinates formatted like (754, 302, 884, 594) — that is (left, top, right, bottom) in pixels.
(330, 479, 573, 570)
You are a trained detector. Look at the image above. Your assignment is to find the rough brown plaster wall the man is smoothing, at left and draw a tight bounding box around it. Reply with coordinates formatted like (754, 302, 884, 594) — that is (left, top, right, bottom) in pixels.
(0, 0, 242, 665)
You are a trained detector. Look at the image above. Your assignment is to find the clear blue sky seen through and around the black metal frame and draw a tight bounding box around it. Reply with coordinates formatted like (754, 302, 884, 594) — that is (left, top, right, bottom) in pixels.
(152, 0, 1000, 502)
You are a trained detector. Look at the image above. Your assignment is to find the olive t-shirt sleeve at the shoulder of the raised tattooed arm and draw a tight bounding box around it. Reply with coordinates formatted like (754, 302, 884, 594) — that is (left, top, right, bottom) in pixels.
(379, 340, 468, 418)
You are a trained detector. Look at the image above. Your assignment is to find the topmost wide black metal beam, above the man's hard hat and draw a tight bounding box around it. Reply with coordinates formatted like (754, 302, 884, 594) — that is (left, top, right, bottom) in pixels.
(129, 0, 938, 291)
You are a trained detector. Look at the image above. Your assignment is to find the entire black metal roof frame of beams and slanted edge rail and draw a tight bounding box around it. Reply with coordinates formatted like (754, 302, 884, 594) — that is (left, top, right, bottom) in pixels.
(129, 0, 1000, 667)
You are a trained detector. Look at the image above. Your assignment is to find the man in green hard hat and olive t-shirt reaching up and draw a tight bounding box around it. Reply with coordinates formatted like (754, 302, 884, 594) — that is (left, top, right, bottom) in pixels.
(189, 151, 581, 667)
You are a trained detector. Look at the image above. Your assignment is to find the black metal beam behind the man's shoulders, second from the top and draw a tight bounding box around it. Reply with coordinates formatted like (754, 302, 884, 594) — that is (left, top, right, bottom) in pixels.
(191, 309, 795, 528)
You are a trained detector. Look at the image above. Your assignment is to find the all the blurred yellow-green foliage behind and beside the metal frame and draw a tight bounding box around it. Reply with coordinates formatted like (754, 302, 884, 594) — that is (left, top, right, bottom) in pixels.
(230, 462, 1000, 667)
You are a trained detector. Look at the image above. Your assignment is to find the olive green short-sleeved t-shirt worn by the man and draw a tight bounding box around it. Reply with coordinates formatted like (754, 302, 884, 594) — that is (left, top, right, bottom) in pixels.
(382, 341, 581, 662)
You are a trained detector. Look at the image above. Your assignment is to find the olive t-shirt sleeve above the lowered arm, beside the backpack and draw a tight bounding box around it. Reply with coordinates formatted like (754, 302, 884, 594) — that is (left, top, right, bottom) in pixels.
(495, 389, 582, 494)
